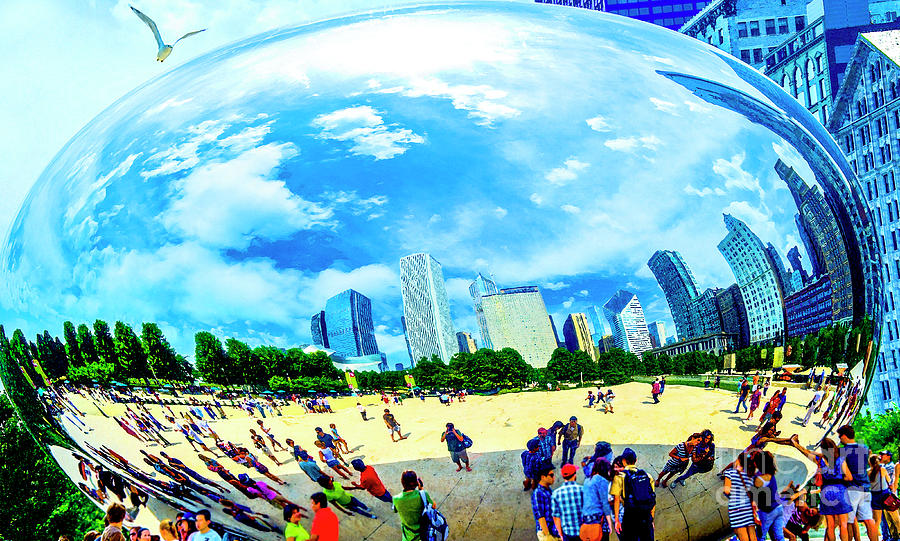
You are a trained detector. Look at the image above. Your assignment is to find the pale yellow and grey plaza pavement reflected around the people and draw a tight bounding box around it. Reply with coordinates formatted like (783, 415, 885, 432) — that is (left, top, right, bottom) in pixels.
(63, 383, 822, 541)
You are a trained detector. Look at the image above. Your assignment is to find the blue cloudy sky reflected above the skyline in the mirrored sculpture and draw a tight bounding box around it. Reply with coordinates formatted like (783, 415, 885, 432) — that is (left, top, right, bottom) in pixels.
(0, 3, 811, 362)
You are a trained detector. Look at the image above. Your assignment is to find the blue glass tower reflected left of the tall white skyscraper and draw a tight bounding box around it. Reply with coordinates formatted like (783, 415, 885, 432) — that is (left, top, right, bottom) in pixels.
(325, 289, 378, 357)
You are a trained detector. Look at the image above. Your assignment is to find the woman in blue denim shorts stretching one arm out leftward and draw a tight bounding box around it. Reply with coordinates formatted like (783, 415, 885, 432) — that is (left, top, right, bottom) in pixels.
(791, 435, 853, 541)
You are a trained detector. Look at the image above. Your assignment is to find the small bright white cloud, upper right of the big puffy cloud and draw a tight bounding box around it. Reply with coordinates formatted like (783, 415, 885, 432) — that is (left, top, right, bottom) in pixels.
(313, 105, 425, 160)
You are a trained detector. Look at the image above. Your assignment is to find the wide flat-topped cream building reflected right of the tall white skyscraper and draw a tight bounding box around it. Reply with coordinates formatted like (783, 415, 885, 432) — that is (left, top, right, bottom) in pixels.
(482, 286, 557, 368)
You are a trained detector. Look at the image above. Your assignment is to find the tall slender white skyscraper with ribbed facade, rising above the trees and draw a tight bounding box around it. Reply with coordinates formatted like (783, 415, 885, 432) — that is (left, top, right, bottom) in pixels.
(400, 254, 459, 363)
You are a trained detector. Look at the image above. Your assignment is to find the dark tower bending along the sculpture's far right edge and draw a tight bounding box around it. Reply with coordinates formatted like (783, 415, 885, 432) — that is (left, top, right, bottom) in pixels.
(775, 160, 853, 321)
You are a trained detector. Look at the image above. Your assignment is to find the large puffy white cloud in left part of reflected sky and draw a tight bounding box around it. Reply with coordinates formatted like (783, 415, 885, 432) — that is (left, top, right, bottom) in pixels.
(161, 143, 332, 249)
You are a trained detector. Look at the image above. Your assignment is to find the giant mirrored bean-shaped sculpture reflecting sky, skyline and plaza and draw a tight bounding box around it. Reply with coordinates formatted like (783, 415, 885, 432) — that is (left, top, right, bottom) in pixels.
(0, 2, 881, 541)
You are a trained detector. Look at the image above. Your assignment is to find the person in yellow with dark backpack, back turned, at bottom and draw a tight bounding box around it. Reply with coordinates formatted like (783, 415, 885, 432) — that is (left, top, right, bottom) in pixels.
(609, 447, 656, 541)
